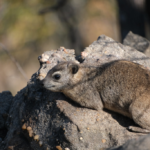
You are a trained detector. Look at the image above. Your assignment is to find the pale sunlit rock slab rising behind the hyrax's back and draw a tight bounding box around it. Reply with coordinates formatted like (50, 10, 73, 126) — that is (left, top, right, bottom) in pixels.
(81, 35, 150, 68)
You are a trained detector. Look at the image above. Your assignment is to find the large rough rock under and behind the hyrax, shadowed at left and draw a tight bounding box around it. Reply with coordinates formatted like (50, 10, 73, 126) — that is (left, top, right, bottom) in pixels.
(0, 35, 150, 150)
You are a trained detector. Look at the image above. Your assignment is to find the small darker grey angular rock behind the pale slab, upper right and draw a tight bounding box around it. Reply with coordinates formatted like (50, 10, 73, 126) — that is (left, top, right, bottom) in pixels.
(123, 31, 150, 57)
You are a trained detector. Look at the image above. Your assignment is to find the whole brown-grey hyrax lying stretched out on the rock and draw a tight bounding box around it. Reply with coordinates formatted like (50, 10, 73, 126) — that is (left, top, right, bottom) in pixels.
(42, 60, 150, 130)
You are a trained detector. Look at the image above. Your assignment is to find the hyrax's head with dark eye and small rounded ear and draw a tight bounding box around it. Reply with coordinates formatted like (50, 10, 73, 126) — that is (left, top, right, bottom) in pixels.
(42, 62, 79, 92)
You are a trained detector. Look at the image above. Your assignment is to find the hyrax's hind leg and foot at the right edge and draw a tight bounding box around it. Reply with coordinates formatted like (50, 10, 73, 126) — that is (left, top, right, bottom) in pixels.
(129, 92, 150, 133)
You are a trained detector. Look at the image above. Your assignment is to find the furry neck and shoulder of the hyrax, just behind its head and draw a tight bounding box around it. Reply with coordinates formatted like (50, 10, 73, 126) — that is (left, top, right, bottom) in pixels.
(63, 66, 99, 109)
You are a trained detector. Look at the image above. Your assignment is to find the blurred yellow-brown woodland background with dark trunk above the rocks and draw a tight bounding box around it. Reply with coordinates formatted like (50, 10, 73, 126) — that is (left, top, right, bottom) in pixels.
(0, 0, 150, 95)
